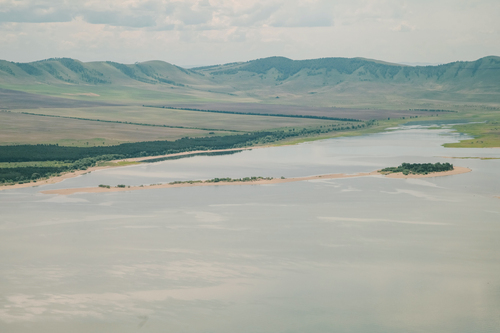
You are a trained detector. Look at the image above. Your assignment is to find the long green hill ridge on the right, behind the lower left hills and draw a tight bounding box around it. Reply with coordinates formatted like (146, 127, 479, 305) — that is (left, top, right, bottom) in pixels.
(194, 57, 500, 106)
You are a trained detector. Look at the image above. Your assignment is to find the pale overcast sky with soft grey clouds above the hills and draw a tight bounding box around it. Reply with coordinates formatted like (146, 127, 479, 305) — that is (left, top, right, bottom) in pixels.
(0, 0, 500, 66)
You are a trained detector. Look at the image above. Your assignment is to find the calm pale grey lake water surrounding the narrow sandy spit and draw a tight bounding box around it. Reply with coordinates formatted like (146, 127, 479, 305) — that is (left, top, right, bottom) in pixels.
(0, 126, 500, 333)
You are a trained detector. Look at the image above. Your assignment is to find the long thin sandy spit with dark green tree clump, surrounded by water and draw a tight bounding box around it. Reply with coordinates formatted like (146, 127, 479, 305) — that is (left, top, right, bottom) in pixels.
(41, 163, 471, 195)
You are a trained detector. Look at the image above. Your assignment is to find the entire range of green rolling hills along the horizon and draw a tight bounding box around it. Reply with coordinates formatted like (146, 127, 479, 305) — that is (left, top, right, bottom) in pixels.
(0, 56, 500, 108)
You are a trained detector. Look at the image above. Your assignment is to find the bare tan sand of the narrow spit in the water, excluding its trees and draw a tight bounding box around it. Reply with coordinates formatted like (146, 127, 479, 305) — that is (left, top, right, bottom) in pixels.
(40, 167, 472, 195)
